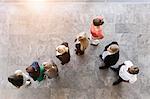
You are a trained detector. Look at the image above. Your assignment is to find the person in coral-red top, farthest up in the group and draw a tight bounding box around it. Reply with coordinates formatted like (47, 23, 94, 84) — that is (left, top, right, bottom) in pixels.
(90, 16, 104, 46)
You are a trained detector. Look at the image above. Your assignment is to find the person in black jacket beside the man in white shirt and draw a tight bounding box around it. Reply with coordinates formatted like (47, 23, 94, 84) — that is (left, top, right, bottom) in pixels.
(99, 42, 119, 69)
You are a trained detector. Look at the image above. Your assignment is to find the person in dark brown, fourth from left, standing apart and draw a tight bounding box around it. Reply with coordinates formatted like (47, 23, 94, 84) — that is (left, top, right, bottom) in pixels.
(56, 42, 70, 65)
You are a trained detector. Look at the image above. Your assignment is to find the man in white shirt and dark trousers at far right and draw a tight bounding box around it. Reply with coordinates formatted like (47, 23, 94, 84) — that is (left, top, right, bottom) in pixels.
(111, 61, 139, 85)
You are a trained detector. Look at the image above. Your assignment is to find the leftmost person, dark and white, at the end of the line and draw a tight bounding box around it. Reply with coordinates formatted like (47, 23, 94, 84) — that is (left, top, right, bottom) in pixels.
(8, 70, 31, 88)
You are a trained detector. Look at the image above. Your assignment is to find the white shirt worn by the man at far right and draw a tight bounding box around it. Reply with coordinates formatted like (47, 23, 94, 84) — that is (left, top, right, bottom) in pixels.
(119, 61, 137, 83)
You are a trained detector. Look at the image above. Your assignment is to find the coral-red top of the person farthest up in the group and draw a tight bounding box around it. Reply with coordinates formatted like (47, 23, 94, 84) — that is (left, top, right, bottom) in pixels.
(90, 16, 104, 39)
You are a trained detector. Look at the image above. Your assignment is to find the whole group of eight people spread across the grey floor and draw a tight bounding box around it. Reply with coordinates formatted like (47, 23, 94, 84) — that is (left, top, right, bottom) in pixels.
(8, 16, 139, 88)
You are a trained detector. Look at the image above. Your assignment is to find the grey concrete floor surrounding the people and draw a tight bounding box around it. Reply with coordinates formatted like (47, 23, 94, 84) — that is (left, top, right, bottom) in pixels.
(0, 0, 150, 99)
